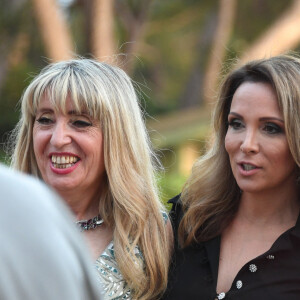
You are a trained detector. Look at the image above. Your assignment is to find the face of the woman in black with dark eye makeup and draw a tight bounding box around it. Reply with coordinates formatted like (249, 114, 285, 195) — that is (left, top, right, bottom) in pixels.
(225, 82, 296, 193)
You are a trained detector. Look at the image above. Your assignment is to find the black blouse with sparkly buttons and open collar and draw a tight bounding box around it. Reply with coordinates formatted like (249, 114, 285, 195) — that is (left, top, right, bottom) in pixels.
(162, 196, 300, 300)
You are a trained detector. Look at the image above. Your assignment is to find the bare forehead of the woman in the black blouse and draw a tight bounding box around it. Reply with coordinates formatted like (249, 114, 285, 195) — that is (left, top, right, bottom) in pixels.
(230, 82, 282, 117)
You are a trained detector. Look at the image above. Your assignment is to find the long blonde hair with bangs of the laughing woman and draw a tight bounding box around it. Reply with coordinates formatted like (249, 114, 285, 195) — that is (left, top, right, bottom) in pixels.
(10, 59, 170, 299)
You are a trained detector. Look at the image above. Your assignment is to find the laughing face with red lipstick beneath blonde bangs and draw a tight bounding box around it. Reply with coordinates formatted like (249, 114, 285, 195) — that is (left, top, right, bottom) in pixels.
(33, 97, 105, 194)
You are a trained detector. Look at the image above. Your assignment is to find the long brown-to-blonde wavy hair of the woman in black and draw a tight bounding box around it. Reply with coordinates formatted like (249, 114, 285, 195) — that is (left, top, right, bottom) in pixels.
(179, 55, 300, 247)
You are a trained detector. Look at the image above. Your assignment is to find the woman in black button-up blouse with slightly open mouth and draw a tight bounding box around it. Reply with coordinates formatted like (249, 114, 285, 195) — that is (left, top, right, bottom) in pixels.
(163, 55, 300, 300)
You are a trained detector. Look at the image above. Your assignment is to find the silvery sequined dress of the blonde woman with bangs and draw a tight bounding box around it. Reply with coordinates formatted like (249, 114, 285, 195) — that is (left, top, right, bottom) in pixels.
(95, 212, 168, 300)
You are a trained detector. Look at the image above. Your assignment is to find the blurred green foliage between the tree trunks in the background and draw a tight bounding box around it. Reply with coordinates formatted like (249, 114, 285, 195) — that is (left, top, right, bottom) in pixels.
(0, 0, 297, 206)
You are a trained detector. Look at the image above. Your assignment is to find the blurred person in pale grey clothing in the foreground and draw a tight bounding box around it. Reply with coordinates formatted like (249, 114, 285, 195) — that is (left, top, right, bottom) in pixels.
(0, 165, 101, 300)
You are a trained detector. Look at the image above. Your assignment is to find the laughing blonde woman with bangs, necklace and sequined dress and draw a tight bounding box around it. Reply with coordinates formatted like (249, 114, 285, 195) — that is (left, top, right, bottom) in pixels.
(11, 59, 172, 299)
